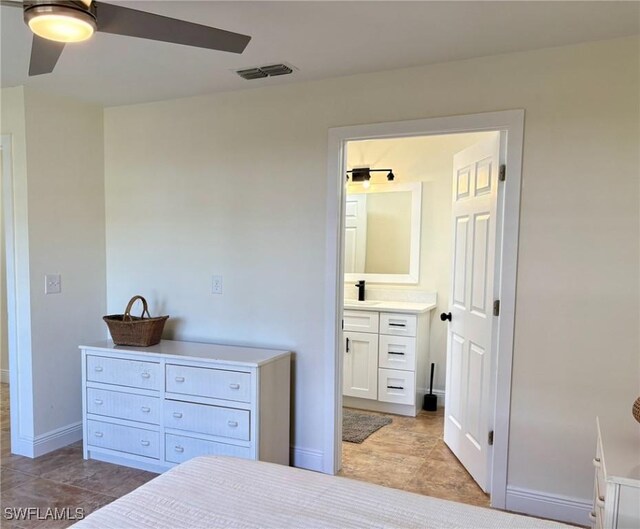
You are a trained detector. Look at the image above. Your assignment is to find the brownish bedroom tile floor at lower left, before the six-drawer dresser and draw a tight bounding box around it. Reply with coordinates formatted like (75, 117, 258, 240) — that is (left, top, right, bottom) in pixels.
(0, 384, 156, 529)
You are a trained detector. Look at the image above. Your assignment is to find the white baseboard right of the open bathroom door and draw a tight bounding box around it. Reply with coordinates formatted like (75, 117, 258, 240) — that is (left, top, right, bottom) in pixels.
(506, 486, 593, 526)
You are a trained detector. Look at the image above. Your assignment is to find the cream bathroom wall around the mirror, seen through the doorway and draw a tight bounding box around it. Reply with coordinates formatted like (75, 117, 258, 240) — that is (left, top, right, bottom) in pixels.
(345, 132, 486, 391)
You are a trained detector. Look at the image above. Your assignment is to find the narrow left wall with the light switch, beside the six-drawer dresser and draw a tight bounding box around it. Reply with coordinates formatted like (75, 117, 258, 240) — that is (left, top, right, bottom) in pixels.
(2, 89, 106, 454)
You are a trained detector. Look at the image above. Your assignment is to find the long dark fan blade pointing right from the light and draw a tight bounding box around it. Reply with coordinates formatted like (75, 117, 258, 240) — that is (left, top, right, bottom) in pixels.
(95, 2, 251, 53)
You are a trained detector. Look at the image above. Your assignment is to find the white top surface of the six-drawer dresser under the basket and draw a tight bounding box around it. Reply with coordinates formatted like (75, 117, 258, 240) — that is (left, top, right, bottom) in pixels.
(79, 340, 291, 366)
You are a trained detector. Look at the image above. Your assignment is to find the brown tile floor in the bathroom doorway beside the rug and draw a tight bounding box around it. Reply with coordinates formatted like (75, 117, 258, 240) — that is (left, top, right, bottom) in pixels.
(340, 408, 489, 507)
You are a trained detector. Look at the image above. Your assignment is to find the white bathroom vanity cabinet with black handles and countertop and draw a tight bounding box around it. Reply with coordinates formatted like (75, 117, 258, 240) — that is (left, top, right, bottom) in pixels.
(342, 300, 436, 417)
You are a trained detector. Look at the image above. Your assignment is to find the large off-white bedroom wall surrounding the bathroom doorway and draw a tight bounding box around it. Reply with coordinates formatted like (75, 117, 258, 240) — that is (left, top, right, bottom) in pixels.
(105, 38, 640, 516)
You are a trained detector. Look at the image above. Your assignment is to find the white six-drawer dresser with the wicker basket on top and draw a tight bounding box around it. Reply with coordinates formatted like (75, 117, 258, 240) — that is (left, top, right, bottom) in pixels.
(80, 340, 291, 472)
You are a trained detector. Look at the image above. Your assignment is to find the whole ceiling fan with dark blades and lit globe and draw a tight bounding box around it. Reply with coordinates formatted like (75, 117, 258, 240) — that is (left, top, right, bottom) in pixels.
(0, 0, 251, 76)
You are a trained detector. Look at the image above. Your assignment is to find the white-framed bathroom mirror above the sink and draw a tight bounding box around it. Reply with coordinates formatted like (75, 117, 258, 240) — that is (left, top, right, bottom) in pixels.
(344, 182, 422, 283)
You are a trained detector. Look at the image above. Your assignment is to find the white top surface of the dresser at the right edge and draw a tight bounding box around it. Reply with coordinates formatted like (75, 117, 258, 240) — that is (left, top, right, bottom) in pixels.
(598, 410, 640, 487)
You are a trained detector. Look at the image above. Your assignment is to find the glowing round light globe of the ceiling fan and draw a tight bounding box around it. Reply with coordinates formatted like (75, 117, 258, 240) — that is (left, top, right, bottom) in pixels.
(25, 6, 96, 42)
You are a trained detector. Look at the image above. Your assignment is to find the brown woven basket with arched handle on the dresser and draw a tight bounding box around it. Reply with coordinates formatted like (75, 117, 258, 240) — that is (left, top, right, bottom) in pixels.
(102, 296, 169, 347)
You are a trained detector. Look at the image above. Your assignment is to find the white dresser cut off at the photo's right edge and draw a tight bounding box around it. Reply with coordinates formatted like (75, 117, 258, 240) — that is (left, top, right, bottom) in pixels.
(590, 411, 640, 529)
